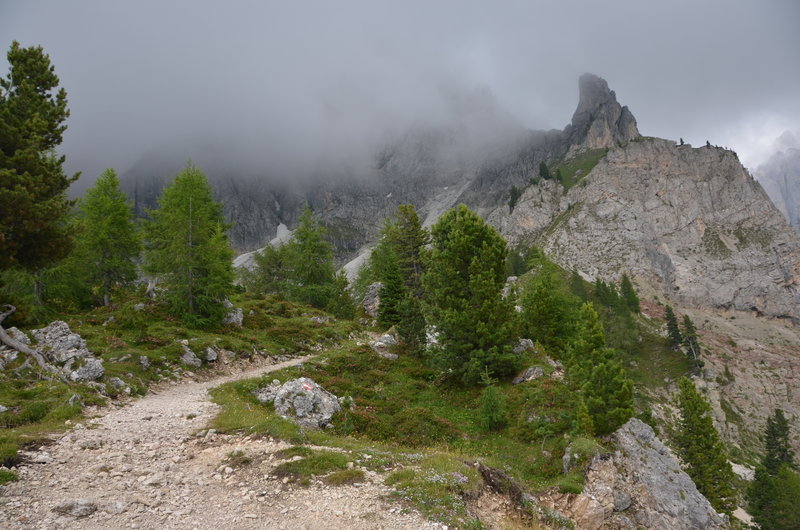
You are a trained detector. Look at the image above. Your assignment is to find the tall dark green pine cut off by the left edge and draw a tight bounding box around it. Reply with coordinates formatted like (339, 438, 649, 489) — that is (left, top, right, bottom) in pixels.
(0, 41, 78, 370)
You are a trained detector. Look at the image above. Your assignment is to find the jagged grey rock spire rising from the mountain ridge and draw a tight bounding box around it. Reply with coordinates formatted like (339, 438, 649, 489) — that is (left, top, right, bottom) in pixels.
(564, 74, 639, 152)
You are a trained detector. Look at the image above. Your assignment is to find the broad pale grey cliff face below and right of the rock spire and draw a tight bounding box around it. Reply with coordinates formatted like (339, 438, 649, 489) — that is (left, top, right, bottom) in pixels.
(500, 139, 800, 322)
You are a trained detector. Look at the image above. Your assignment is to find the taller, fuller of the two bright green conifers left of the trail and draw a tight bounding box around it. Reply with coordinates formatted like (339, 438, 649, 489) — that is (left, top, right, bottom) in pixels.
(145, 165, 234, 325)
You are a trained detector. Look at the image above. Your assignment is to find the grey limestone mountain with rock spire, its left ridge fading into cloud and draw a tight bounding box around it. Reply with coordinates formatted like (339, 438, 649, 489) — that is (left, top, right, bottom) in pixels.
(123, 74, 800, 322)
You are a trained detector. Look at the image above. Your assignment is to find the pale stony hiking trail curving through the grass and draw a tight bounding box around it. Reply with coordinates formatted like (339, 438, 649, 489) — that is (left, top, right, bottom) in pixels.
(0, 357, 442, 530)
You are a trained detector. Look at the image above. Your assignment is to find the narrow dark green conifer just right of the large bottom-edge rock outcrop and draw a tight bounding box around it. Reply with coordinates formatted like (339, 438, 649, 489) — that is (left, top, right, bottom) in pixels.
(676, 377, 736, 513)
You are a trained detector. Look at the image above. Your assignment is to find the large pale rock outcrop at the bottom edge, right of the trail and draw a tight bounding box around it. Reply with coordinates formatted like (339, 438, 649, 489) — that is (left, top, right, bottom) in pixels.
(539, 418, 728, 530)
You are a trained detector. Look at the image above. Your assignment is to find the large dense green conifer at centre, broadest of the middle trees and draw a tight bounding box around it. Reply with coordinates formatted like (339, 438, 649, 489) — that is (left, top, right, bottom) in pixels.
(423, 205, 521, 383)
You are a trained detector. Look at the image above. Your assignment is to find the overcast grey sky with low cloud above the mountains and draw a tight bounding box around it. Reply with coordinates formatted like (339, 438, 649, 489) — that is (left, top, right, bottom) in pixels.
(0, 0, 800, 185)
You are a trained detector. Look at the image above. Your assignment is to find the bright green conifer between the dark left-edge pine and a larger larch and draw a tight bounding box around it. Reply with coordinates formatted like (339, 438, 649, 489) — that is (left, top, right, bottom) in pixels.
(75, 169, 141, 305)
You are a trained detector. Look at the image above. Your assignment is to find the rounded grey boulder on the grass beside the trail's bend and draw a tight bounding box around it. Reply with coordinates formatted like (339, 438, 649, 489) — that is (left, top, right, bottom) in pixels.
(274, 377, 341, 429)
